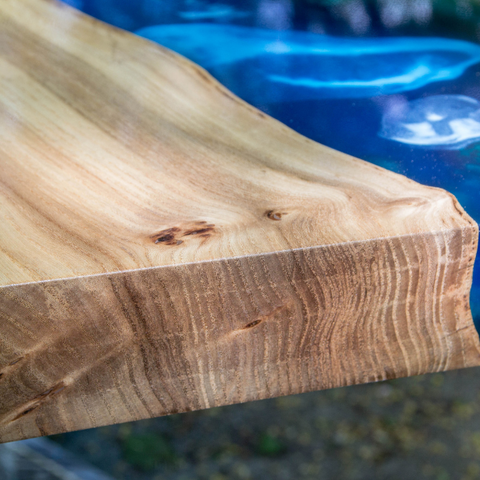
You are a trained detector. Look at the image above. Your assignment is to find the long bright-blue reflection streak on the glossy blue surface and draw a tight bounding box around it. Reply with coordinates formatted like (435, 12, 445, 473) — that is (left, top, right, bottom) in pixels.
(135, 23, 480, 101)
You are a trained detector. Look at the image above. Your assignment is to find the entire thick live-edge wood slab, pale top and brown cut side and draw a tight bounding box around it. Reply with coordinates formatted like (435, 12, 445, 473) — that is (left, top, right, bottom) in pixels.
(0, 0, 480, 442)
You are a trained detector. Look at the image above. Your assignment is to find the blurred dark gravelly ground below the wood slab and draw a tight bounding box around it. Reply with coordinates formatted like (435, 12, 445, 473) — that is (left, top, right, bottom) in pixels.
(50, 368, 480, 480)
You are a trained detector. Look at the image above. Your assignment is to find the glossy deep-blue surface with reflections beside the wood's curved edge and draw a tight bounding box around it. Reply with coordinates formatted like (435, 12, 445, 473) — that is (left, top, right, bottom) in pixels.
(65, 0, 480, 329)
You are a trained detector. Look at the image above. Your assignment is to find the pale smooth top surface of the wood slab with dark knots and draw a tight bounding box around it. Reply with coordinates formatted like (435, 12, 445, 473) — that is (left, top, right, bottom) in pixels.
(0, 0, 472, 286)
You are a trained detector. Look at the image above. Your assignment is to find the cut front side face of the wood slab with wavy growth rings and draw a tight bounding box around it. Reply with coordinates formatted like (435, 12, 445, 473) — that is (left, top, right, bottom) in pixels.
(0, 229, 479, 441)
